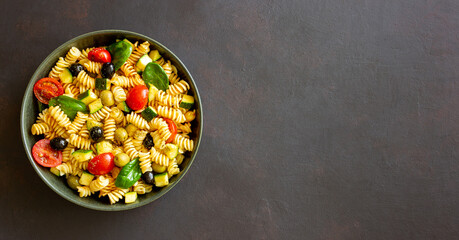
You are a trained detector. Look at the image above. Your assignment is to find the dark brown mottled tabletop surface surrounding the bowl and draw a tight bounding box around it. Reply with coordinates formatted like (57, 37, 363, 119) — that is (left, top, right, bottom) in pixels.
(0, 0, 459, 239)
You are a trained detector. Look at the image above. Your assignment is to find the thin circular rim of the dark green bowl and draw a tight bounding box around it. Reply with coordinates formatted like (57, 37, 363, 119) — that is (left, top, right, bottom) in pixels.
(20, 29, 204, 211)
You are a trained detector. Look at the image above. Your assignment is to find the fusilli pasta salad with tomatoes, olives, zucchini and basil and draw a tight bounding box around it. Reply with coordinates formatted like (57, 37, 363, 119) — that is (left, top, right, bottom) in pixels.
(31, 39, 196, 204)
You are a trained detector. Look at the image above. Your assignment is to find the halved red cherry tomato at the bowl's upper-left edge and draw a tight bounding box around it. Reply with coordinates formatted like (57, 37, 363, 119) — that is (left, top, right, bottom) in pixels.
(33, 78, 64, 104)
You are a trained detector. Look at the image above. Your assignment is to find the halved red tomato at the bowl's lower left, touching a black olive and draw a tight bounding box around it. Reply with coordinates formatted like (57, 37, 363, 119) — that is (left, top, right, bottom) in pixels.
(32, 139, 62, 167)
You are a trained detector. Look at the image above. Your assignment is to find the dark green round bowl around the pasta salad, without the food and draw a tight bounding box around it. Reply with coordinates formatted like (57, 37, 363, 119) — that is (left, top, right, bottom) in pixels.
(21, 30, 203, 211)
